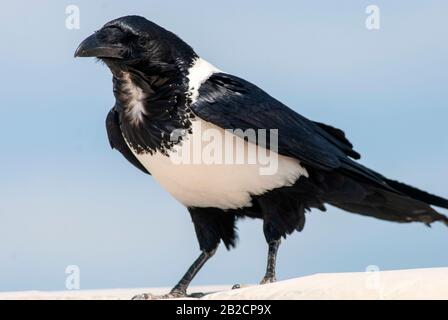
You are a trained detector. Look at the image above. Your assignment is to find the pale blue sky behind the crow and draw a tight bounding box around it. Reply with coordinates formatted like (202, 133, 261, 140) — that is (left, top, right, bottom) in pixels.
(0, 0, 448, 291)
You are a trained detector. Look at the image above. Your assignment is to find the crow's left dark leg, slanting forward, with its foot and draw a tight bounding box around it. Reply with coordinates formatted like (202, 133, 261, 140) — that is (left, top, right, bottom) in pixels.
(132, 249, 216, 300)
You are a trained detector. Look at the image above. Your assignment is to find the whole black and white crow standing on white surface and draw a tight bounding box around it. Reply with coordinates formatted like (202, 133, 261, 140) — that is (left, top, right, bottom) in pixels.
(75, 16, 448, 299)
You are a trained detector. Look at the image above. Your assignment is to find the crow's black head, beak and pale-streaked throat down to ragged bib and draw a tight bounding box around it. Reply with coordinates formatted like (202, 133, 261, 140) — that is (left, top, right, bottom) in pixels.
(75, 16, 198, 152)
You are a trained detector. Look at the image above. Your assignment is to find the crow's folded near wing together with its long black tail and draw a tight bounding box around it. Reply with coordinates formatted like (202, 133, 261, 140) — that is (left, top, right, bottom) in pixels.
(191, 73, 448, 221)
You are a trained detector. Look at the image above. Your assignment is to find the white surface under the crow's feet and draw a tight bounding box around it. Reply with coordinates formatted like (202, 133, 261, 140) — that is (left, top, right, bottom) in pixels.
(0, 268, 448, 300)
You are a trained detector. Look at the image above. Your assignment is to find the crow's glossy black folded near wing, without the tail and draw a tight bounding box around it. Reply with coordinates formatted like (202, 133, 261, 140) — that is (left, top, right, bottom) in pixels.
(191, 73, 391, 189)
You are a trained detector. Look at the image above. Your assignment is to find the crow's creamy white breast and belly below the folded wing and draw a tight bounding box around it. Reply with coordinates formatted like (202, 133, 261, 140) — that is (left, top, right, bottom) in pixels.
(126, 118, 308, 209)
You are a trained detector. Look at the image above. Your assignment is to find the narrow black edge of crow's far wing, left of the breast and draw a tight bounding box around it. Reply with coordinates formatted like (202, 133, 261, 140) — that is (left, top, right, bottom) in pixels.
(106, 107, 150, 174)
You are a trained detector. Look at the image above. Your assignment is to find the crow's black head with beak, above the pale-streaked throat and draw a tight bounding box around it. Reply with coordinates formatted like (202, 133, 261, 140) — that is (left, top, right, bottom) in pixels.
(75, 16, 196, 74)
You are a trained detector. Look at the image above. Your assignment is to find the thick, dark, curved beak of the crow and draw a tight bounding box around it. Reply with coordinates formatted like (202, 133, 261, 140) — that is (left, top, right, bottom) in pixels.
(75, 33, 126, 59)
